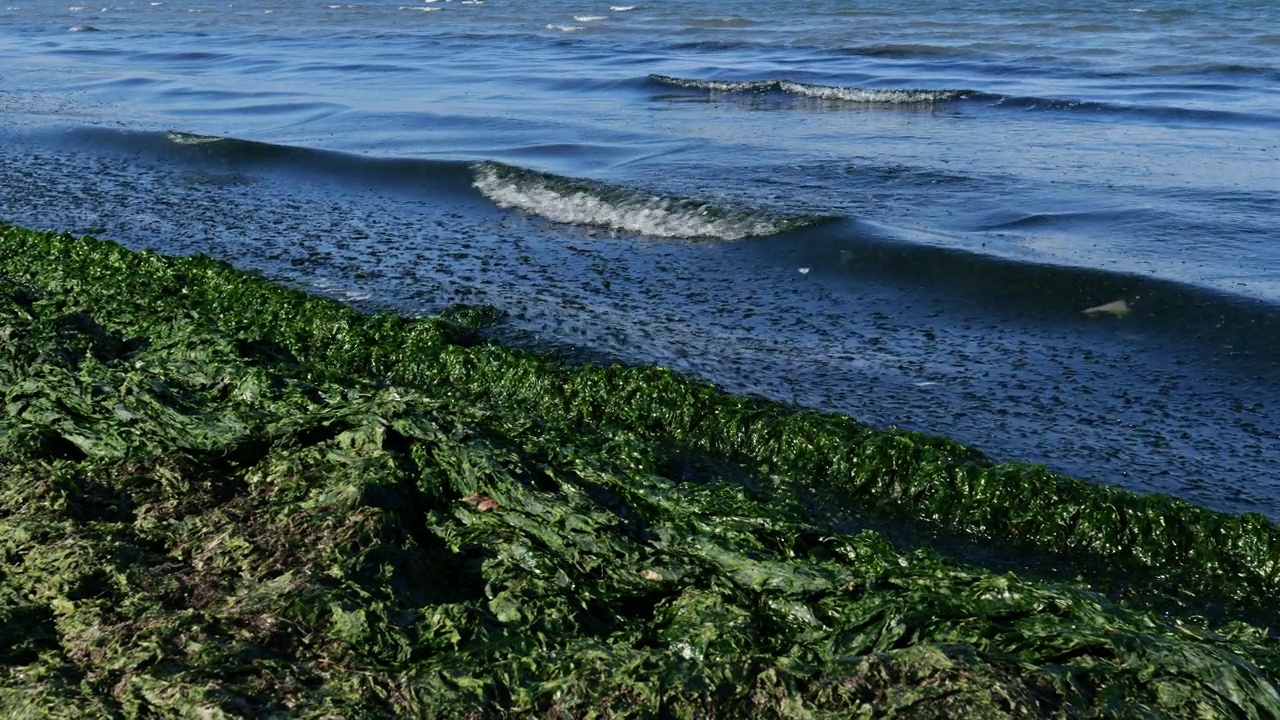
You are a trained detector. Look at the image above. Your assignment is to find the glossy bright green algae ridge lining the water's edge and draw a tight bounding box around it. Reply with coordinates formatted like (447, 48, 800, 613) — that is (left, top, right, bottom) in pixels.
(0, 221, 1280, 614)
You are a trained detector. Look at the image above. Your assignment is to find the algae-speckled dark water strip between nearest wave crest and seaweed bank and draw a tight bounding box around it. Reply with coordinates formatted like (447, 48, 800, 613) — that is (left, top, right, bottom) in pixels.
(0, 124, 1280, 521)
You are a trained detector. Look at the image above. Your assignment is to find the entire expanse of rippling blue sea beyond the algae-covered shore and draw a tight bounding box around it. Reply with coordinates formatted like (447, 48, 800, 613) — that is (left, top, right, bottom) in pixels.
(0, 0, 1280, 519)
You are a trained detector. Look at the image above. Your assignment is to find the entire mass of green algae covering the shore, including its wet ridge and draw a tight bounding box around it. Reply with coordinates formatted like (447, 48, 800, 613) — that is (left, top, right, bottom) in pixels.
(0, 228, 1280, 717)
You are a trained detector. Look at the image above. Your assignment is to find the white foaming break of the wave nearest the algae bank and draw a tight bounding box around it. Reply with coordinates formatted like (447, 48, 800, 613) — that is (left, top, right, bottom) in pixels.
(474, 163, 820, 240)
